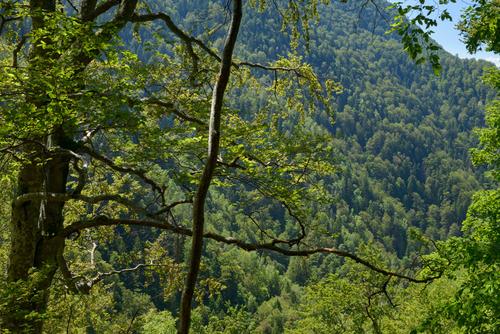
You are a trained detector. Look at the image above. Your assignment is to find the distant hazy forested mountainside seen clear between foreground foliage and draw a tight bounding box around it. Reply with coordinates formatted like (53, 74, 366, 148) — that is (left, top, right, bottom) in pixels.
(234, 0, 492, 250)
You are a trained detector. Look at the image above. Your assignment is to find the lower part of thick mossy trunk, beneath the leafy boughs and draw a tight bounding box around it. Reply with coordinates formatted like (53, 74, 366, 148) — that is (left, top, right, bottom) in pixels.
(2, 131, 69, 333)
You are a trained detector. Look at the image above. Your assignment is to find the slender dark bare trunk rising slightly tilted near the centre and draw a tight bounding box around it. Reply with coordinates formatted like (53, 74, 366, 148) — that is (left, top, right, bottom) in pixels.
(178, 0, 242, 334)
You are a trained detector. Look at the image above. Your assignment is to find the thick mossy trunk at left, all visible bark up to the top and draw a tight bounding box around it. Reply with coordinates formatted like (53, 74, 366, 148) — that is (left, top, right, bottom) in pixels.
(0, 0, 137, 333)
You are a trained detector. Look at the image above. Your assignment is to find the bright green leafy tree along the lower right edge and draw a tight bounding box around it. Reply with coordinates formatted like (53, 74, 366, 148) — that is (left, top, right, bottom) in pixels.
(421, 68, 500, 333)
